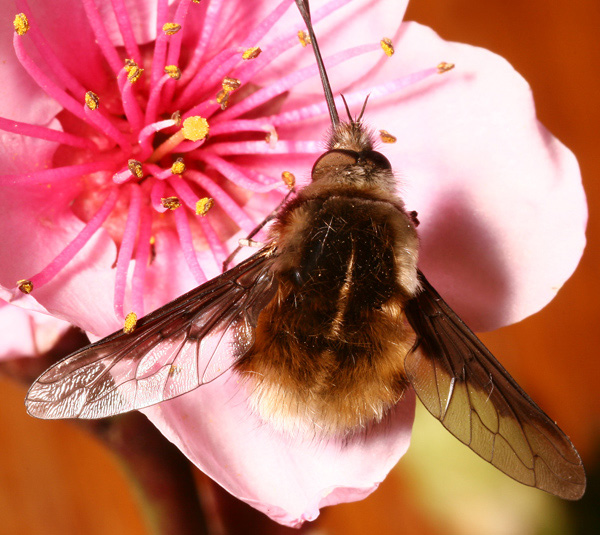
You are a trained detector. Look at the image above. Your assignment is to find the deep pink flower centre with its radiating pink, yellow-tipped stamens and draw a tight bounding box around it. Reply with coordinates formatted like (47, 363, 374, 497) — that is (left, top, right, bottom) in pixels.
(0, 0, 454, 328)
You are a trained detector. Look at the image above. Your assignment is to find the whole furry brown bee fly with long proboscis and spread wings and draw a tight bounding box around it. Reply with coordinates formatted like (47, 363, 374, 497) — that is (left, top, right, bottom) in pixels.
(26, 0, 585, 499)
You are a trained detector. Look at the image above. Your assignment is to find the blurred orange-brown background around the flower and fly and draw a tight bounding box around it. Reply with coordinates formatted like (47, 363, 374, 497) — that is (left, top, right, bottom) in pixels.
(0, 0, 600, 535)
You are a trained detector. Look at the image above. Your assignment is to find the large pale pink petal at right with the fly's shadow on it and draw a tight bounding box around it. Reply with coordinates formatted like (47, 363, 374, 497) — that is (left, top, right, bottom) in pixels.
(288, 23, 587, 330)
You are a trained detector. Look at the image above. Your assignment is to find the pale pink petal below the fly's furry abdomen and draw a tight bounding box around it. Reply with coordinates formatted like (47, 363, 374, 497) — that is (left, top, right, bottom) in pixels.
(142, 373, 415, 527)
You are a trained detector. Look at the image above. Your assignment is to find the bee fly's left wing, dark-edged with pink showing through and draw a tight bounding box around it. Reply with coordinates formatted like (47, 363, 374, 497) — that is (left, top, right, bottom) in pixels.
(25, 249, 277, 419)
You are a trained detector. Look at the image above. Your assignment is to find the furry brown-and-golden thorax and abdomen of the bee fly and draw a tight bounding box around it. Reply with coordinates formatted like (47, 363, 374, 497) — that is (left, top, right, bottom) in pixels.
(236, 198, 416, 435)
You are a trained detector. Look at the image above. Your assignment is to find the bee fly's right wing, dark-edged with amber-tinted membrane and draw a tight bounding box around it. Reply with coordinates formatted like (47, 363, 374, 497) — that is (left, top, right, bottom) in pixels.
(405, 272, 585, 500)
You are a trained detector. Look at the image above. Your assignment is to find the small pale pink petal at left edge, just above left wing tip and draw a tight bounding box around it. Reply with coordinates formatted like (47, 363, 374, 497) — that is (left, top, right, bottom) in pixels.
(0, 300, 70, 360)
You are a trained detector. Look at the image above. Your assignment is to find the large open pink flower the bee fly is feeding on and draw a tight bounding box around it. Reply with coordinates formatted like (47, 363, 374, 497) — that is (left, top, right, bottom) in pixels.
(0, 0, 586, 525)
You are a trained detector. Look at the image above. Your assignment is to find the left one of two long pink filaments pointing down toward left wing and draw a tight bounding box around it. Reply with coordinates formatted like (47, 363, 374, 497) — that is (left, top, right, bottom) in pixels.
(114, 184, 142, 318)
